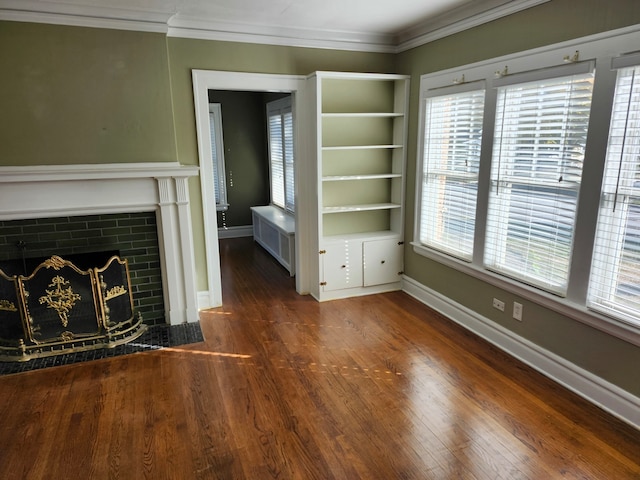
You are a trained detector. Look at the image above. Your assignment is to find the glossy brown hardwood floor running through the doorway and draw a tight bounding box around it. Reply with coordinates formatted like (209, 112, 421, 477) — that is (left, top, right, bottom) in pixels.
(0, 239, 640, 480)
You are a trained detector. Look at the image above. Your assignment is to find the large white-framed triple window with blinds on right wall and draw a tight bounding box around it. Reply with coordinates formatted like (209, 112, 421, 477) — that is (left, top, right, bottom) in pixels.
(412, 29, 640, 344)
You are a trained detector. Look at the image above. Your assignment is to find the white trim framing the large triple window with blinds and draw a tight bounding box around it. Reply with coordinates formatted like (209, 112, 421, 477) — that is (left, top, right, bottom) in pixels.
(411, 26, 640, 346)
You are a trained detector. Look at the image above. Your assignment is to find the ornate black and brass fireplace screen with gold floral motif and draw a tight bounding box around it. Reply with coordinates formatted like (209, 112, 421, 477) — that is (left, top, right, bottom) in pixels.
(0, 256, 146, 361)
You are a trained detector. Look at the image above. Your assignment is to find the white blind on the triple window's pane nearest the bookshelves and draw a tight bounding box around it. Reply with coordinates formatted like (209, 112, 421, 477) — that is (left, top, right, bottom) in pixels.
(419, 89, 485, 260)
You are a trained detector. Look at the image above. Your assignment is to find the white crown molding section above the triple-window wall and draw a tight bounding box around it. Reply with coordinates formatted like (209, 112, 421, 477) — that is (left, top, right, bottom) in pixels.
(395, 0, 550, 53)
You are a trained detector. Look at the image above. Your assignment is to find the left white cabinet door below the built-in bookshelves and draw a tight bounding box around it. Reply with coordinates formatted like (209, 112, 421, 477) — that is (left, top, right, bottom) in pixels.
(321, 240, 362, 292)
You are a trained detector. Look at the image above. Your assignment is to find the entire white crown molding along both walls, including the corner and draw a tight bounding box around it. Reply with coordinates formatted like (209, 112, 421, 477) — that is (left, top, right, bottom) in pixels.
(0, 0, 549, 53)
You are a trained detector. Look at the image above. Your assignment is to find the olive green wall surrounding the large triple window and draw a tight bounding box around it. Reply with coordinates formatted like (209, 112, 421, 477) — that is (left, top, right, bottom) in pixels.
(396, 0, 640, 396)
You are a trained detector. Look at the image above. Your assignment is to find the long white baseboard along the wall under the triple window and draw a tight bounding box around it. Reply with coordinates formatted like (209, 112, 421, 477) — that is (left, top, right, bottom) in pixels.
(402, 276, 640, 429)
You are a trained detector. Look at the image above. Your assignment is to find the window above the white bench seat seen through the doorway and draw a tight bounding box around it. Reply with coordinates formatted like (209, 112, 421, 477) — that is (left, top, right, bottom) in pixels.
(267, 96, 295, 213)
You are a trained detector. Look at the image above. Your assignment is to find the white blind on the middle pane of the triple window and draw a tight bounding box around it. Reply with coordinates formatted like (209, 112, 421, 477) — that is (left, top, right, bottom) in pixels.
(484, 69, 593, 295)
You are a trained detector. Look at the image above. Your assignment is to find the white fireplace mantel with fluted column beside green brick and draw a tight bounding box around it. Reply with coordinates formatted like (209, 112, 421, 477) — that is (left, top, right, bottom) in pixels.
(0, 162, 199, 325)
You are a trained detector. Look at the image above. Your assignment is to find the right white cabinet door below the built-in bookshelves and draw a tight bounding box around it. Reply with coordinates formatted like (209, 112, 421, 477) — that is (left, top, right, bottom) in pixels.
(363, 239, 402, 287)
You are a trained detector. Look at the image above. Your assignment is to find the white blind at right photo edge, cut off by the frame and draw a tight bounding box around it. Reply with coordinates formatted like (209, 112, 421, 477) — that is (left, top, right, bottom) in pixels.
(588, 66, 640, 325)
